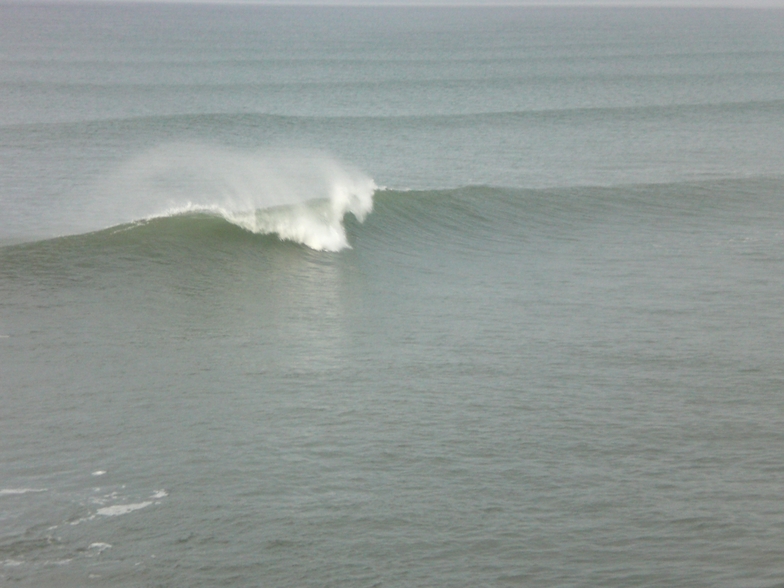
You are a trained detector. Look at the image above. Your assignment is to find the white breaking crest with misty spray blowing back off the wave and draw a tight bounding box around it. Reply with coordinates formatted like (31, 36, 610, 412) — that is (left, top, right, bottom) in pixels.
(91, 143, 377, 251)
